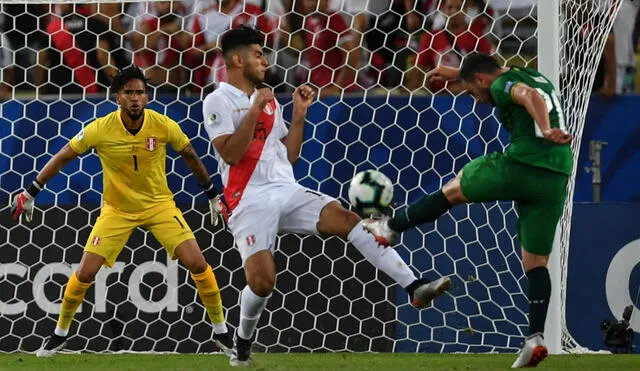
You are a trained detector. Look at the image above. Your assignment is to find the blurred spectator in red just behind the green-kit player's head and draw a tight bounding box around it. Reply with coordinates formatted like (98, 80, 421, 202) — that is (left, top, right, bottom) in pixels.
(405, 0, 495, 94)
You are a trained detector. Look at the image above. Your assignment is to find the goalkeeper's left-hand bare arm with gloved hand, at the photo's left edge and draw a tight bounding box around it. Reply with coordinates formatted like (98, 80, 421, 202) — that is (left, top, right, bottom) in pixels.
(11, 144, 78, 222)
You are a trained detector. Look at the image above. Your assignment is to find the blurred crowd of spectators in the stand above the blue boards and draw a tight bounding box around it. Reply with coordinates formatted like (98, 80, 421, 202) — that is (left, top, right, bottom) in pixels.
(0, 0, 640, 98)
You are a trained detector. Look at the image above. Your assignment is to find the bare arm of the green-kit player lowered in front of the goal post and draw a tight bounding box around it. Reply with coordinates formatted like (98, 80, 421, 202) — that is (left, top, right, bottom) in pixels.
(511, 83, 571, 144)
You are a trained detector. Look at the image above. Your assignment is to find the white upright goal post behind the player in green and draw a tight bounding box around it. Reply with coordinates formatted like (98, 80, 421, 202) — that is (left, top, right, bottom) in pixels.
(537, 0, 571, 354)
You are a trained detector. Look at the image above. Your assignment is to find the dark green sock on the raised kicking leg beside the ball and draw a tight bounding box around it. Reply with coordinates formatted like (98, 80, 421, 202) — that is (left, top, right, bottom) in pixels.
(389, 189, 453, 232)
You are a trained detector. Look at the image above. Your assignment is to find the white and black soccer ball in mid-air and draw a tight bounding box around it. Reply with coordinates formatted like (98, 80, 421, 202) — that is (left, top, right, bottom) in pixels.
(349, 170, 393, 215)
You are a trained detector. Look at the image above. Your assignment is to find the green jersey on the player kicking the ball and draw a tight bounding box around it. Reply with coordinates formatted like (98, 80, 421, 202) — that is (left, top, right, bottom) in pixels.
(491, 67, 573, 175)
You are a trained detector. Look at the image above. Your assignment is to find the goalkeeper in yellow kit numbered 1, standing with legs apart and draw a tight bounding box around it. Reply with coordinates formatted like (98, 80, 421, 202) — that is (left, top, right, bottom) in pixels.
(11, 66, 233, 357)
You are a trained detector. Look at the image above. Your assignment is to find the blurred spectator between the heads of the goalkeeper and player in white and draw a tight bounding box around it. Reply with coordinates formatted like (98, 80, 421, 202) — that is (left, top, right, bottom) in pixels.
(131, 1, 185, 91)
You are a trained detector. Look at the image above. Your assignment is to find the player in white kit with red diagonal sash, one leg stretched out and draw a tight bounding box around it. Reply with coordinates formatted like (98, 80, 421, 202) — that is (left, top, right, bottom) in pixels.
(203, 26, 451, 366)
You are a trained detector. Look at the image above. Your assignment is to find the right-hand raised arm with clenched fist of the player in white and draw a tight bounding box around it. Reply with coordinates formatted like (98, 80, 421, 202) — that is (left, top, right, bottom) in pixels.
(282, 85, 316, 164)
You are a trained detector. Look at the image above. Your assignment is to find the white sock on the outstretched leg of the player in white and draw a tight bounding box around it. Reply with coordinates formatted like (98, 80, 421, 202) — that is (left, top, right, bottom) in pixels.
(347, 221, 417, 288)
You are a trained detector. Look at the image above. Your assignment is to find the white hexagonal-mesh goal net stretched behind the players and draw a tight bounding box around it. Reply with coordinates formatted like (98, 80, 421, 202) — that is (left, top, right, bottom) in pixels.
(0, 0, 620, 352)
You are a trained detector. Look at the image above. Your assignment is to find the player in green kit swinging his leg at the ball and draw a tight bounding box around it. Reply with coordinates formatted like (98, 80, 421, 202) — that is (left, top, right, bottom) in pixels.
(365, 54, 573, 368)
